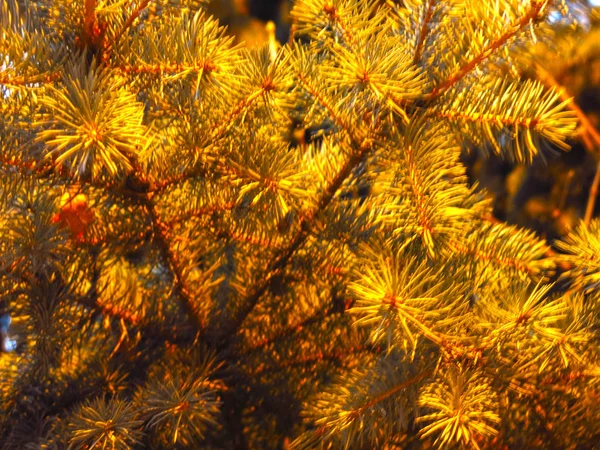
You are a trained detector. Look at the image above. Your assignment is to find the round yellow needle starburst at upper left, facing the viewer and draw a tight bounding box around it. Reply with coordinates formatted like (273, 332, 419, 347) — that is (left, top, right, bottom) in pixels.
(36, 59, 145, 179)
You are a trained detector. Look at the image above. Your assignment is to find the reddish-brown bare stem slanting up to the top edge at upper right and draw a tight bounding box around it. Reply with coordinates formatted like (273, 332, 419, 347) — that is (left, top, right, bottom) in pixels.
(426, 0, 549, 101)
